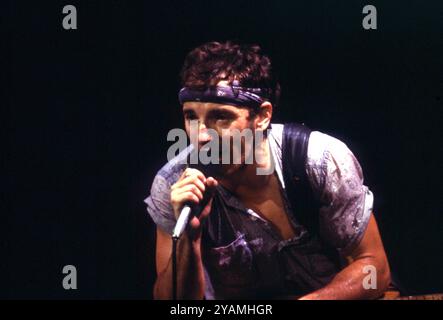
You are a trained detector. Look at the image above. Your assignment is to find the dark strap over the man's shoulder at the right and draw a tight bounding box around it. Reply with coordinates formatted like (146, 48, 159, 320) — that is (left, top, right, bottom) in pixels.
(282, 123, 319, 232)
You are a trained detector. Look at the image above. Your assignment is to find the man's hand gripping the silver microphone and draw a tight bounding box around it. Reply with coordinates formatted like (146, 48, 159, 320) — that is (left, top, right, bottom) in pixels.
(171, 168, 218, 238)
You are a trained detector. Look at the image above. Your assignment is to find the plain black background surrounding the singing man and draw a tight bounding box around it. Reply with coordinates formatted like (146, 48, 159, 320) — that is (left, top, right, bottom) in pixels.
(0, 0, 443, 299)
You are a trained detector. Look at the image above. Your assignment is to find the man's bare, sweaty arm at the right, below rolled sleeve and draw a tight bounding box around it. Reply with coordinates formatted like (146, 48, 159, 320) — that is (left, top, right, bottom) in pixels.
(300, 215, 390, 300)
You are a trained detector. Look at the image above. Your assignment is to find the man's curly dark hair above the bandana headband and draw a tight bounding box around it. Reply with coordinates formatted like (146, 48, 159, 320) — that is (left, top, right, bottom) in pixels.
(180, 41, 280, 110)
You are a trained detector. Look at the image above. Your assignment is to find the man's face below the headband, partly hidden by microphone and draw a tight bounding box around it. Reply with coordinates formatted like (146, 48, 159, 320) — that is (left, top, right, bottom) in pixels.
(183, 101, 255, 176)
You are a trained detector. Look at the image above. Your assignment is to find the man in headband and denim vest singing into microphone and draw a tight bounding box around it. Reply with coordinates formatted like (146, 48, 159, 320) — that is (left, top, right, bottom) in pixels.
(145, 41, 390, 299)
